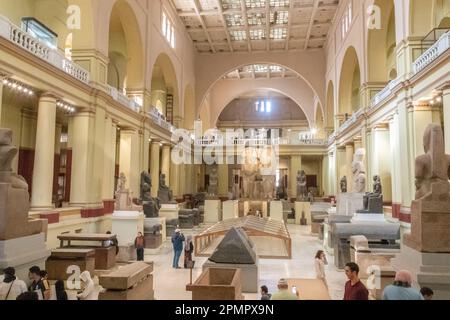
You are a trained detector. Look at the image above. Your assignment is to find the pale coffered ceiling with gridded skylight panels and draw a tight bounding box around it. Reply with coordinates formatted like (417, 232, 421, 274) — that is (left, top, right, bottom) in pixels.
(171, 0, 339, 53)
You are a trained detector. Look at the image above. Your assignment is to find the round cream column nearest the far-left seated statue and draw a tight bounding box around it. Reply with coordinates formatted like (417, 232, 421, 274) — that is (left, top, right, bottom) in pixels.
(31, 94, 56, 211)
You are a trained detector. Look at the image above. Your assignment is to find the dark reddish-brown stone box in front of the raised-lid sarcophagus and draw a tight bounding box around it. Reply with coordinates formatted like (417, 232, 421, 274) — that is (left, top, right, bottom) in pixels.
(45, 249, 95, 280)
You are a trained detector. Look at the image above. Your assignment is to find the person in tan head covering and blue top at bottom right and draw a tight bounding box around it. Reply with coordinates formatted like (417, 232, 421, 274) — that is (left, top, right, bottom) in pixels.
(383, 270, 424, 300)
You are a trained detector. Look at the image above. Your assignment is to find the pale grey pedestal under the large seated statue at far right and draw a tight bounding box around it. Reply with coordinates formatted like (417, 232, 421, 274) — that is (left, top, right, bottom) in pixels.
(392, 245, 450, 300)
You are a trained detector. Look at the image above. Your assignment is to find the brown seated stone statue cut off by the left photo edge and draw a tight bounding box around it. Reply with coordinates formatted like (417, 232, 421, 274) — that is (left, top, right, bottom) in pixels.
(0, 129, 44, 241)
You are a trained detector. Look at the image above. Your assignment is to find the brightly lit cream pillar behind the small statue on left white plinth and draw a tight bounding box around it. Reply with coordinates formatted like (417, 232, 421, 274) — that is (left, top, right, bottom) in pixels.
(119, 129, 140, 198)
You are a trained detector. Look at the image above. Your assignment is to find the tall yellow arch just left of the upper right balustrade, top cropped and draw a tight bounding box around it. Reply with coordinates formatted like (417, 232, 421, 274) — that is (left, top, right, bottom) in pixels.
(367, 0, 397, 82)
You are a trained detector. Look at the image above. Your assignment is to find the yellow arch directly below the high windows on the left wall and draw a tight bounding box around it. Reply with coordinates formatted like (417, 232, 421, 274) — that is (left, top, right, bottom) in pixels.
(151, 53, 181, 127)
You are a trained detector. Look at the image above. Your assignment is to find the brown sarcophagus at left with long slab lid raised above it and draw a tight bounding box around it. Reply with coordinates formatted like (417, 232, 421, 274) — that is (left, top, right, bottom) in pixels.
(58, 233, 117, 270)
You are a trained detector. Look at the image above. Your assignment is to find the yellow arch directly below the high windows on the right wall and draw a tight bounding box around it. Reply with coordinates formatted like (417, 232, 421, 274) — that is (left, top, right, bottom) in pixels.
(338, 47, 361, 115)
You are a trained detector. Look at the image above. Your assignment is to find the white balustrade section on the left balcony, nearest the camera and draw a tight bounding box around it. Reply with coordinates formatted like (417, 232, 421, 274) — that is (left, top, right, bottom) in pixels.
(0, 15, 90, 84)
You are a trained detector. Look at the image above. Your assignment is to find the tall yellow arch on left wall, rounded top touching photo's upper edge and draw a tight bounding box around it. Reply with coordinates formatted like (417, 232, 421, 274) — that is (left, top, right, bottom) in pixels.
(108, 0, 144, 94)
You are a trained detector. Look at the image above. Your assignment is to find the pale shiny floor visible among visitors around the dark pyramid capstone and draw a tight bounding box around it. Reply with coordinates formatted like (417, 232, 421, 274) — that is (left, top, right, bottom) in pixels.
(145, 225, 346, 300)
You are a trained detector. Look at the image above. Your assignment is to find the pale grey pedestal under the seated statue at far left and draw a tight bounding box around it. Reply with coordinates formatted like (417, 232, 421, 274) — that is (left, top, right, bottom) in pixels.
(0, 233, 50, 282)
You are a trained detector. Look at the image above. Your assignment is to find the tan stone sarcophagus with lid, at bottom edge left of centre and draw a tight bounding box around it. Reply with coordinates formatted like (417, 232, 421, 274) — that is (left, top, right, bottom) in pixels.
(99, 262, 154, 300)
